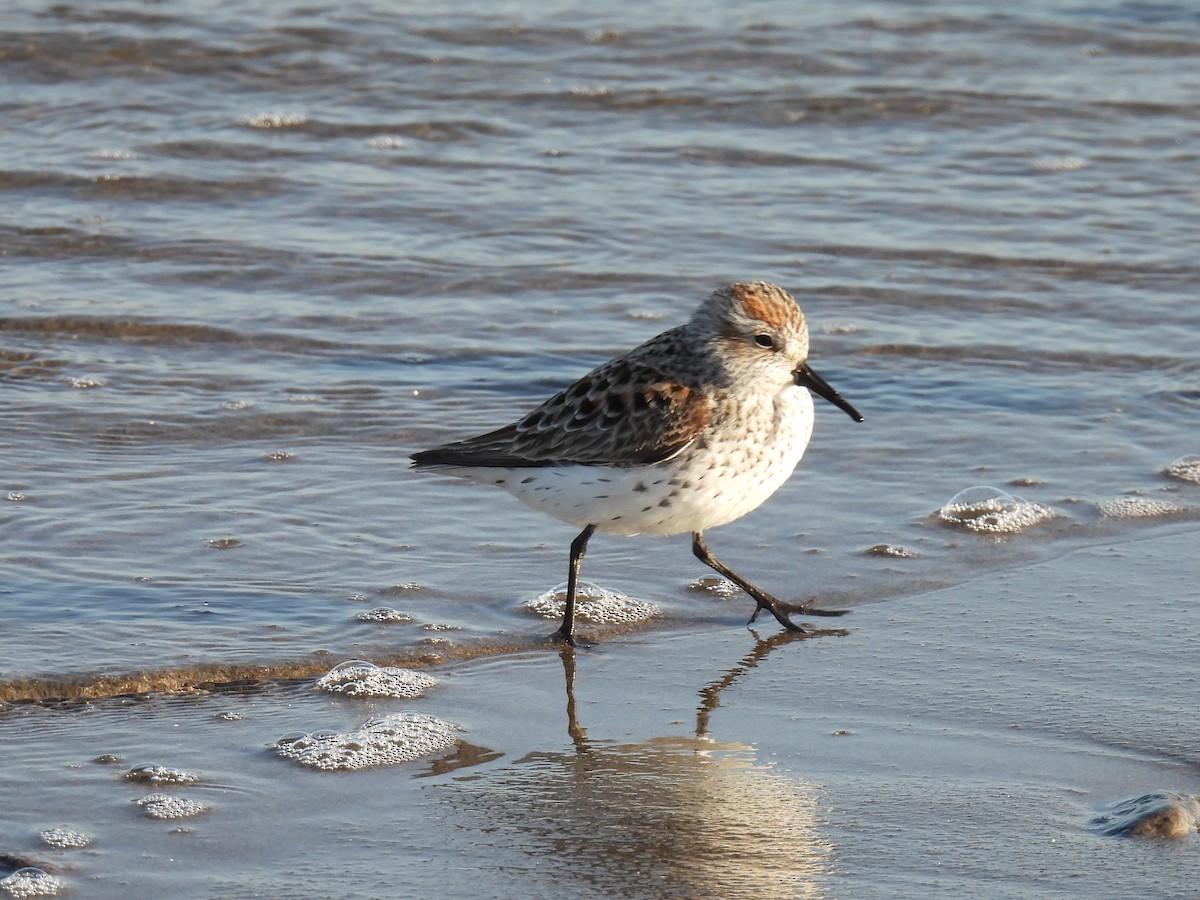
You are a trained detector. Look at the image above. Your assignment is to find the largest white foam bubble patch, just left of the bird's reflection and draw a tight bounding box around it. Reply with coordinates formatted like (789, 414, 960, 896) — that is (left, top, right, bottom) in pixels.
(272, 713, 460, 772)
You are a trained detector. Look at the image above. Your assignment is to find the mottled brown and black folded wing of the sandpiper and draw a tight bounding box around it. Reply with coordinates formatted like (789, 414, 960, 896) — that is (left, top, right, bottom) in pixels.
(413, 345, 713, 467)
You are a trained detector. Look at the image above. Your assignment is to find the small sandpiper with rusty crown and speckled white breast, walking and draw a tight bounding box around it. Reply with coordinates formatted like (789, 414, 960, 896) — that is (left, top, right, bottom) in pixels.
(413, 281, 863, 643)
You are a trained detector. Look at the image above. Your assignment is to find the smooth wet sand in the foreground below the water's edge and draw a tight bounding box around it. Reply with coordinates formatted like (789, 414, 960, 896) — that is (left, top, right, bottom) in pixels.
(0, 528, 1200, 898)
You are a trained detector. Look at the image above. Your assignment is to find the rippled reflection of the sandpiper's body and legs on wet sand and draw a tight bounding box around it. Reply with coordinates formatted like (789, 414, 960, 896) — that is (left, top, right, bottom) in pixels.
(436, 631, 830, 898)
